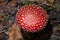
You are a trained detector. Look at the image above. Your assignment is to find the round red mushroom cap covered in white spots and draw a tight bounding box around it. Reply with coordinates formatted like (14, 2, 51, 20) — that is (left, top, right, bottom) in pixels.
(16, 4, 48, 32)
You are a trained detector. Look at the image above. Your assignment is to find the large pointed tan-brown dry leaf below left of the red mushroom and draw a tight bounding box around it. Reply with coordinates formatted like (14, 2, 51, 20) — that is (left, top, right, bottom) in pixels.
(7, 23, 23, 40)
